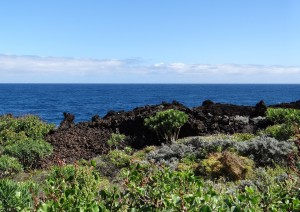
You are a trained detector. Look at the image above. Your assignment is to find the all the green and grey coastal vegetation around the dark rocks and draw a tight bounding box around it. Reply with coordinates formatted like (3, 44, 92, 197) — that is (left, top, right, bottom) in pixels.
(0, 109, 300, 212)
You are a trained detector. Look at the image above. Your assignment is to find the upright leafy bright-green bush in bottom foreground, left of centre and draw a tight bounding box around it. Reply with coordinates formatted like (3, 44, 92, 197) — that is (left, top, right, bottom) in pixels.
(40, 165, 101, 211)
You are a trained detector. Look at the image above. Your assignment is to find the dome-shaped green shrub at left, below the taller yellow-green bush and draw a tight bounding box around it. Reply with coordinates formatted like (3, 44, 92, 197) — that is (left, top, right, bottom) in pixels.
(3, 139, 53, 169)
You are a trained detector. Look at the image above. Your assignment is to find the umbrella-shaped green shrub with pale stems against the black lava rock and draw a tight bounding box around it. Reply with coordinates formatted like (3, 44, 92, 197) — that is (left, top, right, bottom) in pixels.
(145, 109, 188, 143)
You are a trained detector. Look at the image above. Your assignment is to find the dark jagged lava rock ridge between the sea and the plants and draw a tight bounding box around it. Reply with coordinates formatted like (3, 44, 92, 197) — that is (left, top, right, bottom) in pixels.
(42, 100, 300, 166)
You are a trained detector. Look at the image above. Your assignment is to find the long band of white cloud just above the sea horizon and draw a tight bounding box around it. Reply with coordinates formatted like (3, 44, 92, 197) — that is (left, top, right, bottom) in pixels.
(0, 54, 300, 83)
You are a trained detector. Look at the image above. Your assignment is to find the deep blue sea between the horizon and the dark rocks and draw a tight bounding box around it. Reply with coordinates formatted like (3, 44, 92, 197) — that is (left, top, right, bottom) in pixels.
(0, 84, 300, 125)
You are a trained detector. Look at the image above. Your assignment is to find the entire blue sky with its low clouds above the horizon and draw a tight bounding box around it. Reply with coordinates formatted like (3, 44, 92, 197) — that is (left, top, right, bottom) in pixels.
(0, 0, 300, 83)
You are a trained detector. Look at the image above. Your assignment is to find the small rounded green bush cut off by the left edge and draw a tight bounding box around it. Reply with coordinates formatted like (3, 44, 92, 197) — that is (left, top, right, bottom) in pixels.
(0, 155, 23, 178)
